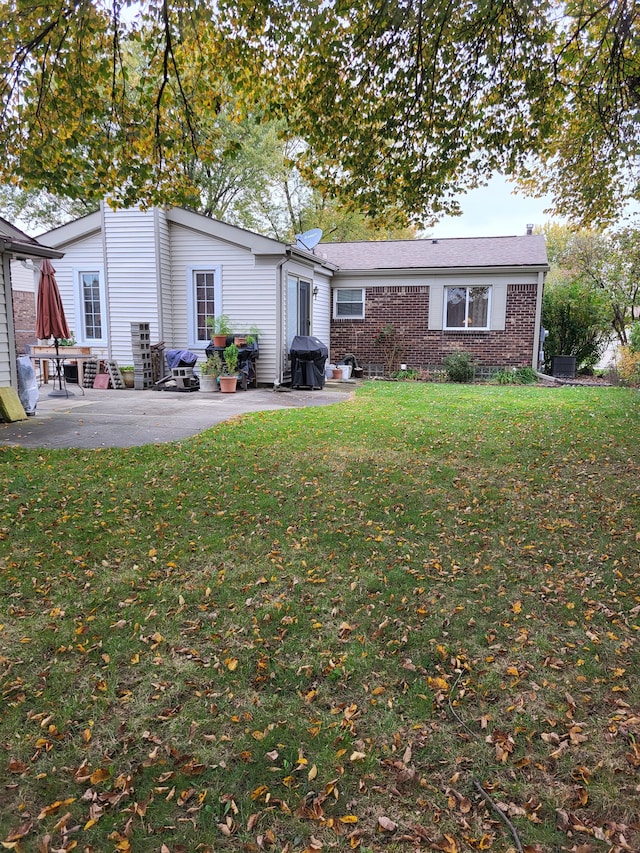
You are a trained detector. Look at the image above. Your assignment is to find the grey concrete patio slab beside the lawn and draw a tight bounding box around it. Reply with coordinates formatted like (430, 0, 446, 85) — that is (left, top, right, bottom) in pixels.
(0, 383, 354, 449)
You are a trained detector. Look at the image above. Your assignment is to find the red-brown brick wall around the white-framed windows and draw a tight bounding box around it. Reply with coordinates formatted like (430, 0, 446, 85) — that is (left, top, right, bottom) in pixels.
(330, 284, 536, 369)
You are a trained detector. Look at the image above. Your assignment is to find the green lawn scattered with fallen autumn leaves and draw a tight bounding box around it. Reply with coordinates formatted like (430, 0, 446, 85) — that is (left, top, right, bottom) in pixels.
(0, 383, 640, 853)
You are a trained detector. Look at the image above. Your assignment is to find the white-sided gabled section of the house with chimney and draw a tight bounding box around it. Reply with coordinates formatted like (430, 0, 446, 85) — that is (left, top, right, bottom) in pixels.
(38, 204, 334, 384)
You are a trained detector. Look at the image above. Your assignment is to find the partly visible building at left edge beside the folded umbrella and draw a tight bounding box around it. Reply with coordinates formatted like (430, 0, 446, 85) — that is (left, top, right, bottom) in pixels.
(0, 218, 62, 389)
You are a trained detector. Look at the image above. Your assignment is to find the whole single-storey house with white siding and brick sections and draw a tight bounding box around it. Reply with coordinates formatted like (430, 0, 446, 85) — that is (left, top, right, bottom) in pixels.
(30, 204, 548, 385)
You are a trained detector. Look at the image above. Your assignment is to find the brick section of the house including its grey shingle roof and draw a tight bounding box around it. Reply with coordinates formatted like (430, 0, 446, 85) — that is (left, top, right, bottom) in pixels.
(316, 233, 549, 368)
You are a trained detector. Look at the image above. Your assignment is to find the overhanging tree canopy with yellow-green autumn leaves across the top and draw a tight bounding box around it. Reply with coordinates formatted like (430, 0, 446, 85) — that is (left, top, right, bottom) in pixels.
(0, 0, 640, 223)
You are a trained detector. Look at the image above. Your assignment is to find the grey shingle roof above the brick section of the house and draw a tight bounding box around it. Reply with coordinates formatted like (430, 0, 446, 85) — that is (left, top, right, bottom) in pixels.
(316, 234, 548, 271)
